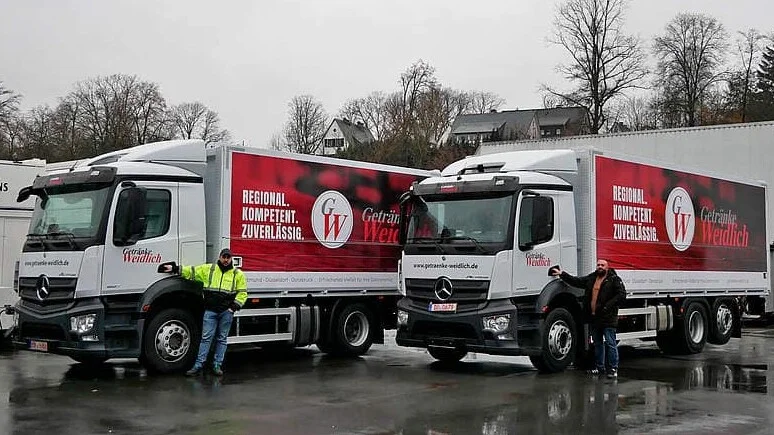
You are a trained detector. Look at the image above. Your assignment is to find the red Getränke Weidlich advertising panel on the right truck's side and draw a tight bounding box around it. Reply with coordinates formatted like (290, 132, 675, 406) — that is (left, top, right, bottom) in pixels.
(595, 156, 768, 272)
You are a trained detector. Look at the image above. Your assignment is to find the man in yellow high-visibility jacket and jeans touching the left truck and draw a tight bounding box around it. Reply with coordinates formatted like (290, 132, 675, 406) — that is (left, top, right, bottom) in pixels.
(164, 248, 247, 376)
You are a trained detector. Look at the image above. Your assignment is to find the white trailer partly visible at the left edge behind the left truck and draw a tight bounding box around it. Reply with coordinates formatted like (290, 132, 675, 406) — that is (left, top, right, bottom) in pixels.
(0, 159, 46, 336)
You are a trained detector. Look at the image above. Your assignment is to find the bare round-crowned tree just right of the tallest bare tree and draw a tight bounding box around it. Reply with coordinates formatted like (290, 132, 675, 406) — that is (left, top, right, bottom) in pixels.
(653, 14, 727, 126)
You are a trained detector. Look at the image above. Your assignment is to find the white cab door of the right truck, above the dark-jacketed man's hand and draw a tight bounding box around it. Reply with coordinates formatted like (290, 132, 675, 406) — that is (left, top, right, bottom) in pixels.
(513, 191, 561, 294)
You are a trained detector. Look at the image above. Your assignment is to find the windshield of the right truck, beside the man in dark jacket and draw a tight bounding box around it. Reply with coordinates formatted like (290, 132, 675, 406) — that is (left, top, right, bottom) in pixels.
(406, 195, 513, 244)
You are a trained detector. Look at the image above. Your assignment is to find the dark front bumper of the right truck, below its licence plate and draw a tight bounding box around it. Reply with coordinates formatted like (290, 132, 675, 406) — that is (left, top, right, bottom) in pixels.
(396, 298, 541, 355)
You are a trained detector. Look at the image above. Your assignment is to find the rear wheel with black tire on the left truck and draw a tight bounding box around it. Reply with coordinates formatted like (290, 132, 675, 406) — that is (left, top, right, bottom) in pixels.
(331, 303, 376, 356)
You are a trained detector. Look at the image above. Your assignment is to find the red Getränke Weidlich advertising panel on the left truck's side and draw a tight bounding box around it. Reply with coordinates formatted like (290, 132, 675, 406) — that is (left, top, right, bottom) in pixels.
(231, 153, 419, 273)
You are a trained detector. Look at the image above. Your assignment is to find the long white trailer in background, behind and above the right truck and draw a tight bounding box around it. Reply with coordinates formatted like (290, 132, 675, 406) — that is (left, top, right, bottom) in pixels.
(476, 122, 774, 316)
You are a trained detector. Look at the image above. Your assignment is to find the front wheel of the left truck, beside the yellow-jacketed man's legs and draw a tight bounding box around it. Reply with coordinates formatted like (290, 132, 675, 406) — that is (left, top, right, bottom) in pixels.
(140, 308, 201, 373)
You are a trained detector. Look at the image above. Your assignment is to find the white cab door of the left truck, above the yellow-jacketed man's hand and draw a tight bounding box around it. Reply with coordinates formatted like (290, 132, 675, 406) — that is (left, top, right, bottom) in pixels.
(102, 181, 179, 294)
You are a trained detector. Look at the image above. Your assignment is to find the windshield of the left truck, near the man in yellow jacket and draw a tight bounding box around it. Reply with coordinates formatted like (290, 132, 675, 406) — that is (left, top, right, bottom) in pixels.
(25, 187, 110, 250)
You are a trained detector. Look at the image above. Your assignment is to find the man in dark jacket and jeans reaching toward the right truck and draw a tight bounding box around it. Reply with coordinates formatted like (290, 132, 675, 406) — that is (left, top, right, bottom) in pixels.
(551, 260, 626, 378)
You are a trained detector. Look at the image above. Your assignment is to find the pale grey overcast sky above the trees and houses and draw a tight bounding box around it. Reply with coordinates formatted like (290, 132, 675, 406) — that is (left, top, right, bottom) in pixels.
(0, 0, 774, 146)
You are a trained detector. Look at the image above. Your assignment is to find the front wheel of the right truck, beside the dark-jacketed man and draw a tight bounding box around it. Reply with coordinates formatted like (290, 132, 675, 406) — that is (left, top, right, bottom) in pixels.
(530, 308, 578, 373)
